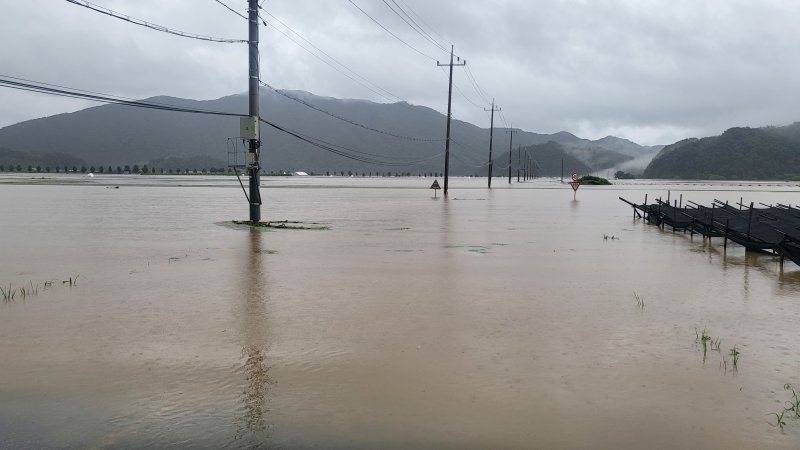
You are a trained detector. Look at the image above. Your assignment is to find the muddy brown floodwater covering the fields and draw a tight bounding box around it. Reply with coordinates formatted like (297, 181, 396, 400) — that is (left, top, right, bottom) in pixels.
(0, 175, 800, 449)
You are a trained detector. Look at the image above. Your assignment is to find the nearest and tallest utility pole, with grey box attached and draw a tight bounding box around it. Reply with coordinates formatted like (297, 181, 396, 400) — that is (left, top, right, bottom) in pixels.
(247, 0, 261, 222)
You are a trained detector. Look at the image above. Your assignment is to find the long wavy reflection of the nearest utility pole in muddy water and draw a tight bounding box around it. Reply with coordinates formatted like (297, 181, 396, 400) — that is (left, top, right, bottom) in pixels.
(236, 229, 274, 440)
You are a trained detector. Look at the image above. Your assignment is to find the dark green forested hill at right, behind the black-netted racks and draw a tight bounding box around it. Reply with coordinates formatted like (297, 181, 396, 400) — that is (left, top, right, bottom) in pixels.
(644, 122, 800, 180)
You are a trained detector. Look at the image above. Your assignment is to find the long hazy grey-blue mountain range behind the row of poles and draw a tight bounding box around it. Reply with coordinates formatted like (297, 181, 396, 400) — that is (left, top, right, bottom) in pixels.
(0, 89, 658, 176)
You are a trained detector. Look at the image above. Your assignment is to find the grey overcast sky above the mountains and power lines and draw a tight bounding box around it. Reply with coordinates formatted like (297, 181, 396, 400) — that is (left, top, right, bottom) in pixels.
(0, 0, 800, 145)
